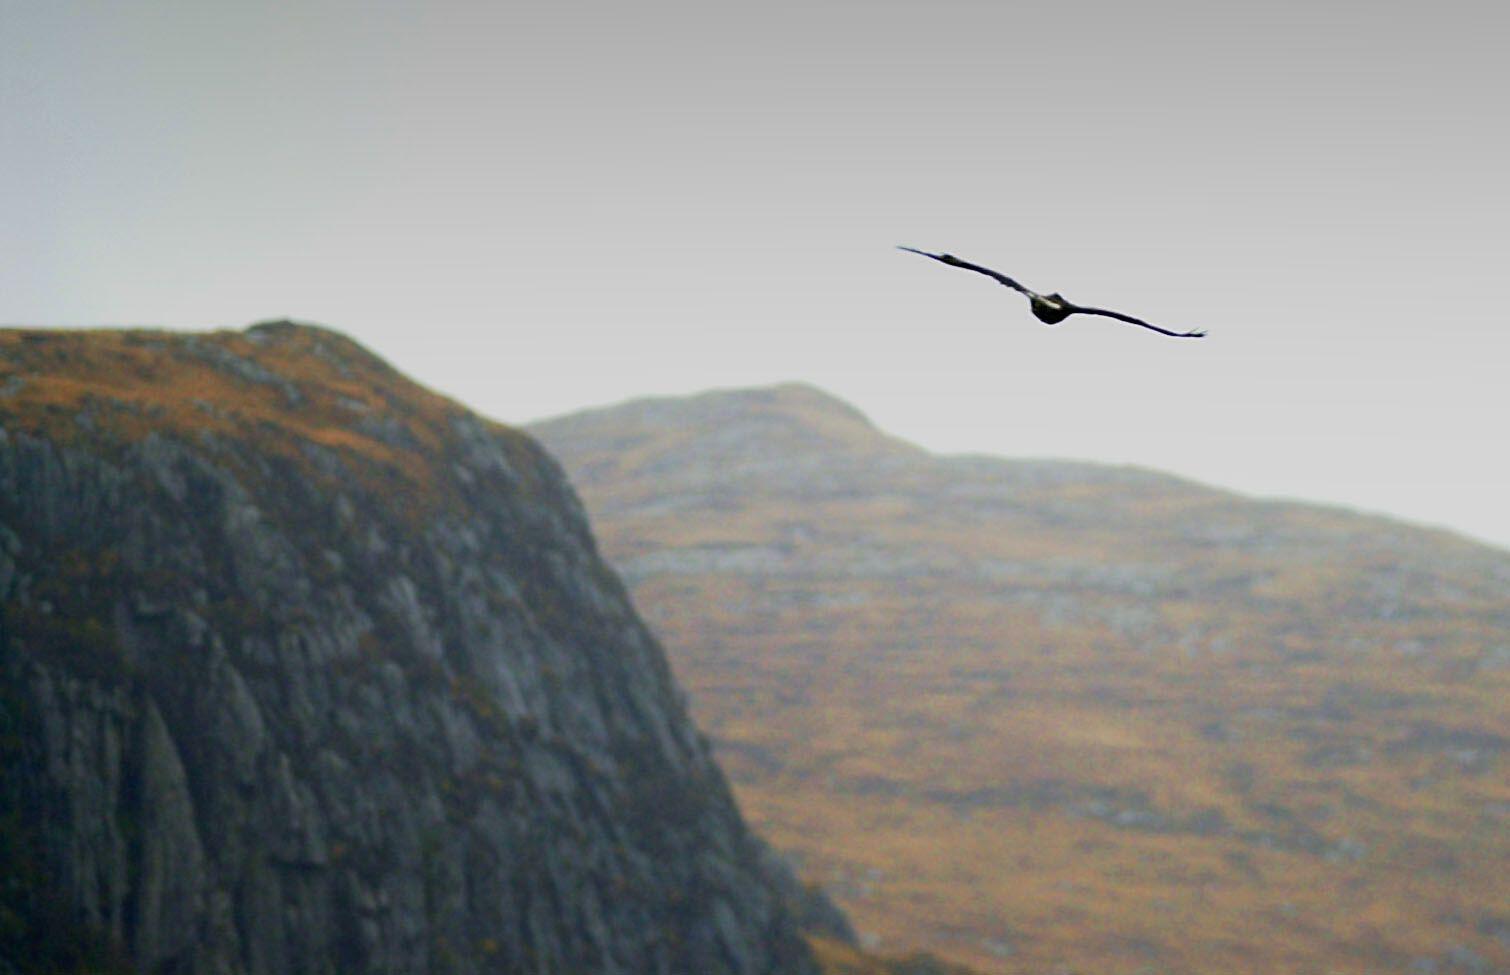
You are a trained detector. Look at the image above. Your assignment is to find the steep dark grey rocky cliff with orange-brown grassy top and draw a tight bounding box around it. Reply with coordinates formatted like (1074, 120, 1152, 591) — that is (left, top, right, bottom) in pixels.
(0, 323, 811, 975)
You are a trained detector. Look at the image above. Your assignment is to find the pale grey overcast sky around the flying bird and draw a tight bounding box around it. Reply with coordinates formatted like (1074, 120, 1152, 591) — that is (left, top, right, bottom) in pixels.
(0, 0, 1510, 546)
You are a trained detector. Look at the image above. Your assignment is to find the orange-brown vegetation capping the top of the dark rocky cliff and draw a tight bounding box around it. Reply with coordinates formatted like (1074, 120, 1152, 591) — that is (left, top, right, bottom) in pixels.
(0, 321, 533, 509)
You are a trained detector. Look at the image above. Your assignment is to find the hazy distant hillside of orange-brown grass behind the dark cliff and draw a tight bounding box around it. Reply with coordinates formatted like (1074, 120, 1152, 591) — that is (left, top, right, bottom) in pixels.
(532, 386, 1510, 975)
